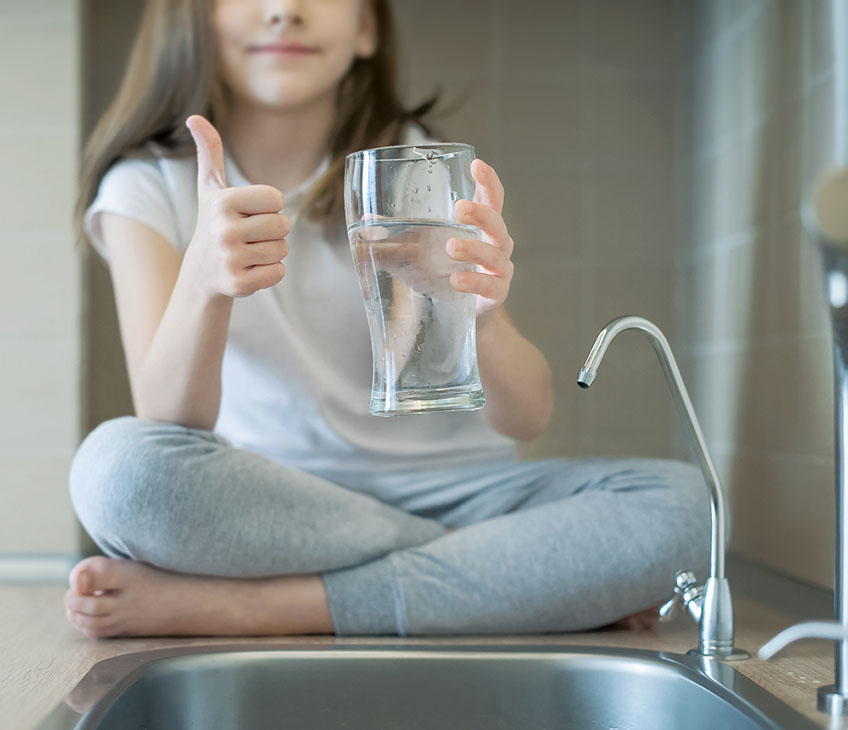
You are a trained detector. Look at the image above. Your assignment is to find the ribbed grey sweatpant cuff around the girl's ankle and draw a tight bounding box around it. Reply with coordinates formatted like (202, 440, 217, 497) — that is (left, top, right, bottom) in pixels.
(321, 555, 405, 636)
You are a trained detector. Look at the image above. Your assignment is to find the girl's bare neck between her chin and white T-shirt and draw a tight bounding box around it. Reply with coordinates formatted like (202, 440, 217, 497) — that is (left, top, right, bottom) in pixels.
(222, 95, 335, 193)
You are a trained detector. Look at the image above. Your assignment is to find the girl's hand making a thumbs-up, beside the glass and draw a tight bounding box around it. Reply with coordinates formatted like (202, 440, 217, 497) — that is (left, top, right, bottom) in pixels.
(183, 114, 291, 298)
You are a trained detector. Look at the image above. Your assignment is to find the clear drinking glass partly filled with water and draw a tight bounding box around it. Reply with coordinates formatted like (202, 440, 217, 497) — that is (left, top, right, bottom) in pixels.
(345, 144, 486, 416)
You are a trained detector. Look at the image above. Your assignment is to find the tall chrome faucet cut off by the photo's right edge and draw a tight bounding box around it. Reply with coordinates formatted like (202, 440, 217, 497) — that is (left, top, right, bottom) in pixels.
(759, 167, 848, 715)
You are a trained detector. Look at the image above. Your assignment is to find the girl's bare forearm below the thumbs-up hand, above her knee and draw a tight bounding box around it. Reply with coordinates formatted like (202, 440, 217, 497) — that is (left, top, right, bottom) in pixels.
(134, 269, 233, 431)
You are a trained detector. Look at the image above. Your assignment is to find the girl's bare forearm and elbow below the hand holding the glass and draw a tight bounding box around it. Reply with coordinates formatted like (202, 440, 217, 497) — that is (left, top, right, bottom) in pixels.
(477, 306, 554, 441)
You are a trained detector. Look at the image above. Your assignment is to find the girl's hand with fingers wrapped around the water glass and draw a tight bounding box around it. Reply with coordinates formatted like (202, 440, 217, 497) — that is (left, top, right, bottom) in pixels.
(445, 159, 515, 330)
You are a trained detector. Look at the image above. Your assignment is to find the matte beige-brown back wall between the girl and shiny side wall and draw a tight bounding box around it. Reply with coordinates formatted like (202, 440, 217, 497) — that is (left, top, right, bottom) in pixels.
(395, 0, 691, 457)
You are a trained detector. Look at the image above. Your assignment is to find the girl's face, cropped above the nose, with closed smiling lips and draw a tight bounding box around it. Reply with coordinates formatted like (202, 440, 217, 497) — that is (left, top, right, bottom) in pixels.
(212, 0, 377, 109)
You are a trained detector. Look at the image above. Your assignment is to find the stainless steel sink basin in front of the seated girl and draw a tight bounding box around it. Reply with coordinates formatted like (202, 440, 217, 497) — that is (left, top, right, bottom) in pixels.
(38, 643, 818, 730)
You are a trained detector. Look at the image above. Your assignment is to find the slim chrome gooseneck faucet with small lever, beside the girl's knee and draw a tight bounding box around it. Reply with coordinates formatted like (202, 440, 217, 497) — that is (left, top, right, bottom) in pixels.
(577, 316, 751, 661)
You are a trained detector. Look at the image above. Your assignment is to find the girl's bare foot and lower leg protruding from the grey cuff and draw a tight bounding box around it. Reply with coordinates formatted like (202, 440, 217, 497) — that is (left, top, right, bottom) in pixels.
(65, 556, 334, 638)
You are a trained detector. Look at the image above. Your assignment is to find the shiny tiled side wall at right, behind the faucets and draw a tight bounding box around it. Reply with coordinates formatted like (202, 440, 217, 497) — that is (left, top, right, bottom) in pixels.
(674, 0, 834, 587)
